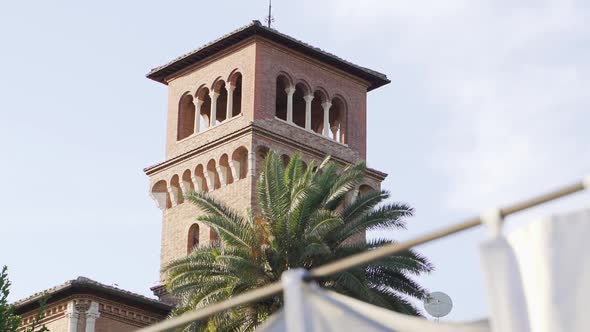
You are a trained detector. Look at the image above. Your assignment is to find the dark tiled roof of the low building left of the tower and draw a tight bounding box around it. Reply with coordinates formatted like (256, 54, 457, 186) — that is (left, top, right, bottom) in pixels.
(13, 277, 172, 314)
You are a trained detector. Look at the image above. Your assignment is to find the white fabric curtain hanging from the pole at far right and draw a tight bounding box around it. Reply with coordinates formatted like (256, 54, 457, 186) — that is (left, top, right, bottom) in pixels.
(481, 209, 590, 332)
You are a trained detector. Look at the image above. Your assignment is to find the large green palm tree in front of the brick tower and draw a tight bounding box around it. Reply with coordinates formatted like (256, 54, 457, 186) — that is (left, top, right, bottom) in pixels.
(165, 152, 432, 331)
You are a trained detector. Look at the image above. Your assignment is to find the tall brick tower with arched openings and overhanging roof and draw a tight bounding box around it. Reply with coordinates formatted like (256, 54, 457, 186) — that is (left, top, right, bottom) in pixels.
(144, 21, 390, 300)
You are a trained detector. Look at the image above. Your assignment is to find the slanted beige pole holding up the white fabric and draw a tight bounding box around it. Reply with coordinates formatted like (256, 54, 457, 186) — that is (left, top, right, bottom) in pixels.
(140, 178, 590, 332)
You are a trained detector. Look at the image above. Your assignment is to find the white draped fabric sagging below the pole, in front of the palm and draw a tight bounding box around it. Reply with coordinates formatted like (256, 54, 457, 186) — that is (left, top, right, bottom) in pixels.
(256, 268, 490, 332)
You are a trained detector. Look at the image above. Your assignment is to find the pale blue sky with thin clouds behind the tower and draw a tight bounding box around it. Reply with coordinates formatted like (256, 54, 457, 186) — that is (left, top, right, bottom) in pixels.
(0, 0, 590, 320)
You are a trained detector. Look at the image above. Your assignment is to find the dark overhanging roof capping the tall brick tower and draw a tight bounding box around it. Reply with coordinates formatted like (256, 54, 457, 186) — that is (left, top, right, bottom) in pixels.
(146, 21, 390, 91)
